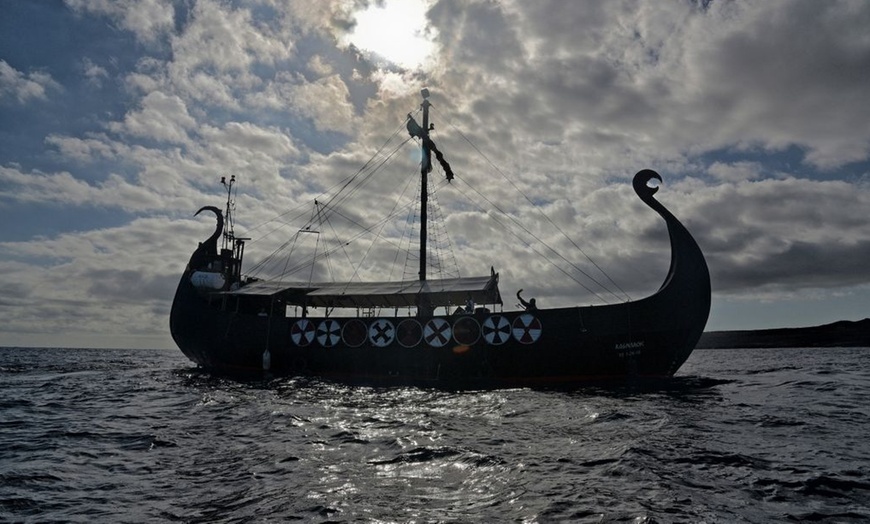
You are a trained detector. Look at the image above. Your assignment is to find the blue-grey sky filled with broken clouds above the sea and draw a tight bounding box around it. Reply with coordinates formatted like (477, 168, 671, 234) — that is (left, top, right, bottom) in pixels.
(0, 0, 870, 348)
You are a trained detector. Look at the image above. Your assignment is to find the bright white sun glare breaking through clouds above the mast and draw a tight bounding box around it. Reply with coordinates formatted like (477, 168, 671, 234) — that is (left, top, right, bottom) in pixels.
(343, 0, 435, 69)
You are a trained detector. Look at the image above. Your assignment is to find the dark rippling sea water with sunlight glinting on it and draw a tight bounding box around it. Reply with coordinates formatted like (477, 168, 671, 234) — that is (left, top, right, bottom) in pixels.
(0, 348, 870, 523)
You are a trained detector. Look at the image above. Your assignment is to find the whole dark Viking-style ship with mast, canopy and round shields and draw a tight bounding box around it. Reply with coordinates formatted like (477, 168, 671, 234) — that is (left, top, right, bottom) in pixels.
(170, 89, 710, 389)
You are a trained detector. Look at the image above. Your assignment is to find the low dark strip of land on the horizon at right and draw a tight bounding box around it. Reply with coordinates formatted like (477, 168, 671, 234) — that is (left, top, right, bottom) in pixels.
(697, 318, 870, 349)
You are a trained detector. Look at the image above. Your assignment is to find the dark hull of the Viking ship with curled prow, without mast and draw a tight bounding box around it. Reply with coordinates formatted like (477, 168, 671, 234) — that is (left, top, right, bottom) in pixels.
(170, 170, 710, 389)
